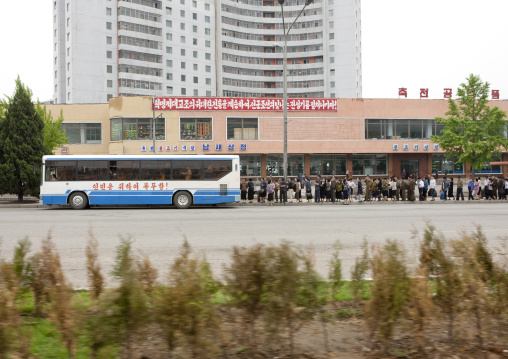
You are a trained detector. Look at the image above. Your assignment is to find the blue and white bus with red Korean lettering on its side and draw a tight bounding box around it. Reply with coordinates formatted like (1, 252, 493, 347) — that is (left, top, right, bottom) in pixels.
(40, 155, 240, 209)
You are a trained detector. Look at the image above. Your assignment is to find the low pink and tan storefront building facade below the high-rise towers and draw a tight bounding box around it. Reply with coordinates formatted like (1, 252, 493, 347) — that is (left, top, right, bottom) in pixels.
(48, 97, 508, 177)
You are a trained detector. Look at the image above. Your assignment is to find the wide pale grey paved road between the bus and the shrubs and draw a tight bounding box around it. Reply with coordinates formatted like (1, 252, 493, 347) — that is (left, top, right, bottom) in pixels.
(0, 201, 508, 287)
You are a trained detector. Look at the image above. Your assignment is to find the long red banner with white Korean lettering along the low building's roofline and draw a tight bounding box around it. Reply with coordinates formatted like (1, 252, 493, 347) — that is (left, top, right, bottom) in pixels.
(153, 97, 337, 111)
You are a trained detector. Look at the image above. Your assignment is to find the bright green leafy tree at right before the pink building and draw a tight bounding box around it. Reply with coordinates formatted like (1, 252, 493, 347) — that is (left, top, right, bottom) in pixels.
(431, 74, 508, 173)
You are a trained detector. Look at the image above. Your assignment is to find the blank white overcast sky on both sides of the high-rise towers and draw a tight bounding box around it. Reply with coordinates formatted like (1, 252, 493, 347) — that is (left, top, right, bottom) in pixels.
(0, 0, 508, 101)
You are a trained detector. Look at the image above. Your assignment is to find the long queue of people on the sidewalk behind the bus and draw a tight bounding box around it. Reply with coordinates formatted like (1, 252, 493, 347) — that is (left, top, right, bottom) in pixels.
(240, 175, 508, 206)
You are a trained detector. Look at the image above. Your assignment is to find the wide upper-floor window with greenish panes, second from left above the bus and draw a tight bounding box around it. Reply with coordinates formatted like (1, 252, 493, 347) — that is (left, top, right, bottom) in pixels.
(111, 117, 166, 141)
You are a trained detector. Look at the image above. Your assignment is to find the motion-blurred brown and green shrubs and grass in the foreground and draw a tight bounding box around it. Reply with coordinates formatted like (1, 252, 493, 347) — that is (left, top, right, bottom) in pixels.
(0, 225, 508, 359)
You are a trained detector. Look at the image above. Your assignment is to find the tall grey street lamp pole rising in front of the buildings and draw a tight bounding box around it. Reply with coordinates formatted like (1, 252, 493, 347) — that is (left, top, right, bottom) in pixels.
(278, 0, 314, 190)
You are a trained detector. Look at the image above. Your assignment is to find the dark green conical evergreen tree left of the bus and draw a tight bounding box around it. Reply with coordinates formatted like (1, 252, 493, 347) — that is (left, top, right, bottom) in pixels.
(0, 77, 44, 201)
